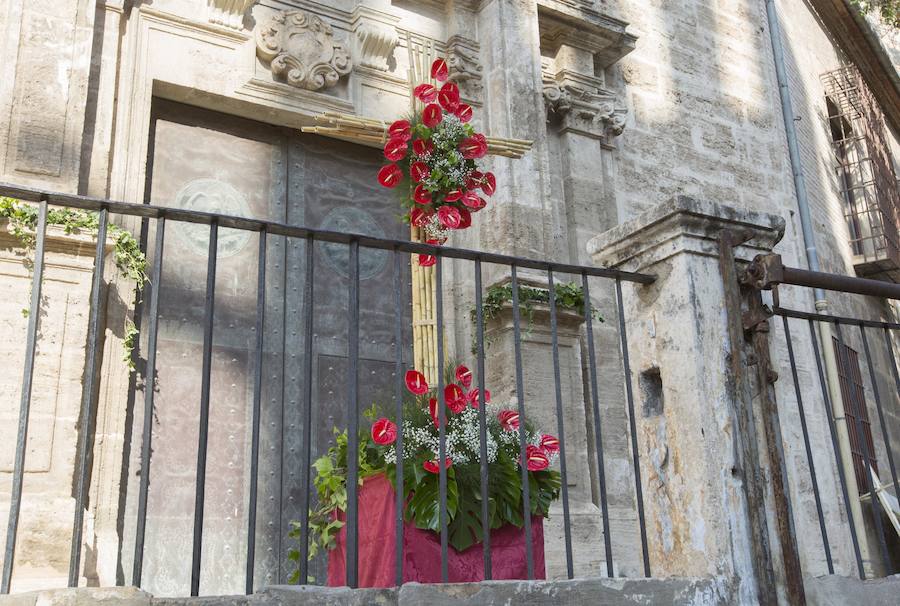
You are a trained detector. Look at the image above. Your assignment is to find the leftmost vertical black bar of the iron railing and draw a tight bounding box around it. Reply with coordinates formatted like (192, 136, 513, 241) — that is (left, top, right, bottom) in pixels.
(0, 200, 47, 594)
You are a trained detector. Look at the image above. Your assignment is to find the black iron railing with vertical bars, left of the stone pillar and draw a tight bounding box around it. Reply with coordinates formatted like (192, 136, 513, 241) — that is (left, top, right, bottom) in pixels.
(0, 185, 654, 595)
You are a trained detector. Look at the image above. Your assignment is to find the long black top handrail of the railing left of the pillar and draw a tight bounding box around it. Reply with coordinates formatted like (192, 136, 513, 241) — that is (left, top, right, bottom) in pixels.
(0, 183, 656, 284)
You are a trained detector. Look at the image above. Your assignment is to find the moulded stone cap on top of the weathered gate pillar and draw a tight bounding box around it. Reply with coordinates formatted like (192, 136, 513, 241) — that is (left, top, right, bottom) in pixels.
(587, 196, 785, 271)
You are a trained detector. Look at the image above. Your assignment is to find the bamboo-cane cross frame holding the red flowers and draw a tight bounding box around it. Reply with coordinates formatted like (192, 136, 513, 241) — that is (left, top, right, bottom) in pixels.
(300, 32, 532, 384)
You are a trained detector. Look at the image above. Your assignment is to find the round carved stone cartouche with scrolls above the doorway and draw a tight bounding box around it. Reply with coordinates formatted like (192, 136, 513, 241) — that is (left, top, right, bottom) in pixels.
(256, 10, 353, 90)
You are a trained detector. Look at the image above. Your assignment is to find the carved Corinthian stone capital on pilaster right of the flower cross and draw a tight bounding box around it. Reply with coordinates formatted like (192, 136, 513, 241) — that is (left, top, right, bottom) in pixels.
(543, 73, 628, 137)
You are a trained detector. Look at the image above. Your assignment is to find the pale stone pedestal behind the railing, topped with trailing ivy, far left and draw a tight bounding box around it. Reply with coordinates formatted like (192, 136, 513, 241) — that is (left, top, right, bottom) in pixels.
(0, 221, 134, 592)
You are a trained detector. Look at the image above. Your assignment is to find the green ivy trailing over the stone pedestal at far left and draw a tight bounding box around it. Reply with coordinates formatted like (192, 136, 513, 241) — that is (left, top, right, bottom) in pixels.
(0, 197, 149, 372)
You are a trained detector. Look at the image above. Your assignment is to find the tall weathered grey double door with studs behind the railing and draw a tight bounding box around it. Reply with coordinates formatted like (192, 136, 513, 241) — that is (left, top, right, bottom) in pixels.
(135, 101, 411, 595)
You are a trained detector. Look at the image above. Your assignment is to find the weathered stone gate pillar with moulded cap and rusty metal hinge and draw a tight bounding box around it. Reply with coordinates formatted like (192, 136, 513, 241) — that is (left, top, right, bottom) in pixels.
(588, 197, 784, 604)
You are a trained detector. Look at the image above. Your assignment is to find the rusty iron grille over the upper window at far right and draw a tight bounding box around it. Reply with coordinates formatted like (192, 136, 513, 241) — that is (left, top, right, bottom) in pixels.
(822, 66, 900, 282)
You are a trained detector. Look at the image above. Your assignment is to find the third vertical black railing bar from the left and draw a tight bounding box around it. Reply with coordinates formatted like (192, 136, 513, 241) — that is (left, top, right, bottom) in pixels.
(131, 217, 166, 587)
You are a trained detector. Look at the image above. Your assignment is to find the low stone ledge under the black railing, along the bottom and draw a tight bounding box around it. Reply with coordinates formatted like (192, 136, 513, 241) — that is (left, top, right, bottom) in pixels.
(0, 578, 734, 606)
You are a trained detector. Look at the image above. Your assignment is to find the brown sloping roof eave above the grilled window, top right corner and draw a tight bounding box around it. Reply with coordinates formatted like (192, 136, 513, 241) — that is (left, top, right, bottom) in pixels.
(809, 0, 900, 131)
